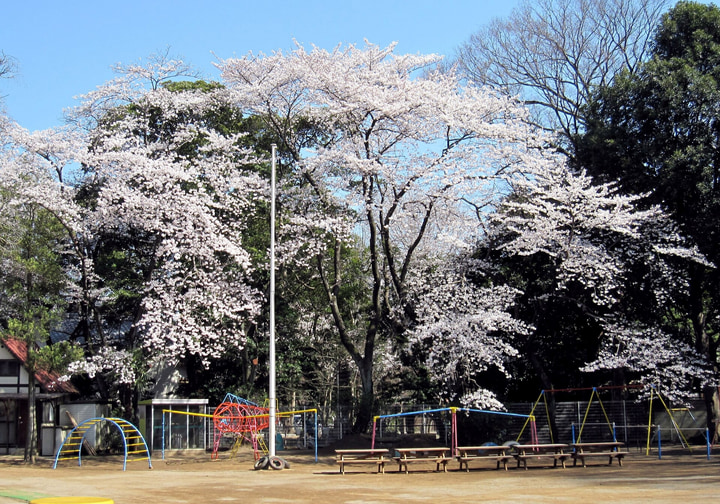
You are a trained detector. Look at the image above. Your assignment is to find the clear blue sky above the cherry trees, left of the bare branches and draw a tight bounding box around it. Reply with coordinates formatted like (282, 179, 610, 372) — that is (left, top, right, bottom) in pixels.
(0, 0, 518, 130)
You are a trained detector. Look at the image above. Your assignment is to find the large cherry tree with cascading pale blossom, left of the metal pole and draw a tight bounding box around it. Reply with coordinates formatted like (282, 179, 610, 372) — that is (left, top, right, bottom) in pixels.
(2, 62, 267, 416)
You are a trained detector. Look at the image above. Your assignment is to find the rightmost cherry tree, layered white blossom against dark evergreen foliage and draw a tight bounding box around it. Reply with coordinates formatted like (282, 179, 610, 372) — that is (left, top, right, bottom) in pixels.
(488, 164, 710, 397)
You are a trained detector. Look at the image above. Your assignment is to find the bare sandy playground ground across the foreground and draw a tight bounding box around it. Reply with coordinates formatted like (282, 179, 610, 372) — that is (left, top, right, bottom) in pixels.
(0, 451, 720, 504)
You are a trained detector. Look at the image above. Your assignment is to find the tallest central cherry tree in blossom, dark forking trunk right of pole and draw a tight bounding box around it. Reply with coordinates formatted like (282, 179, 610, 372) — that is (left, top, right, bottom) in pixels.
(219, 44, 545, 431)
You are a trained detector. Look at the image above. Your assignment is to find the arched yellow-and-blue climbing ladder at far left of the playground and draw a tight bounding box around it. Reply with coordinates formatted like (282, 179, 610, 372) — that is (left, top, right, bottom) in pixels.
(53, 417, 152, 471)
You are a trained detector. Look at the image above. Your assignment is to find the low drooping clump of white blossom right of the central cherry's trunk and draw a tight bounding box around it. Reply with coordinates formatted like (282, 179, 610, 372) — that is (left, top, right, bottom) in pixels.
(409, 256, 532, 410)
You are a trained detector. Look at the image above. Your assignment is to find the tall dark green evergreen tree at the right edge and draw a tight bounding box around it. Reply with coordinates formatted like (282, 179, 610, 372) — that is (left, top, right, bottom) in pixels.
(576, 2, 720, 354)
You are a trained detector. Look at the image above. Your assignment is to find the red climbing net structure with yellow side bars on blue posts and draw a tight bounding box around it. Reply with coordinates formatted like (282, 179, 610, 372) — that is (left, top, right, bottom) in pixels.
(161, 394, 318, 460)
